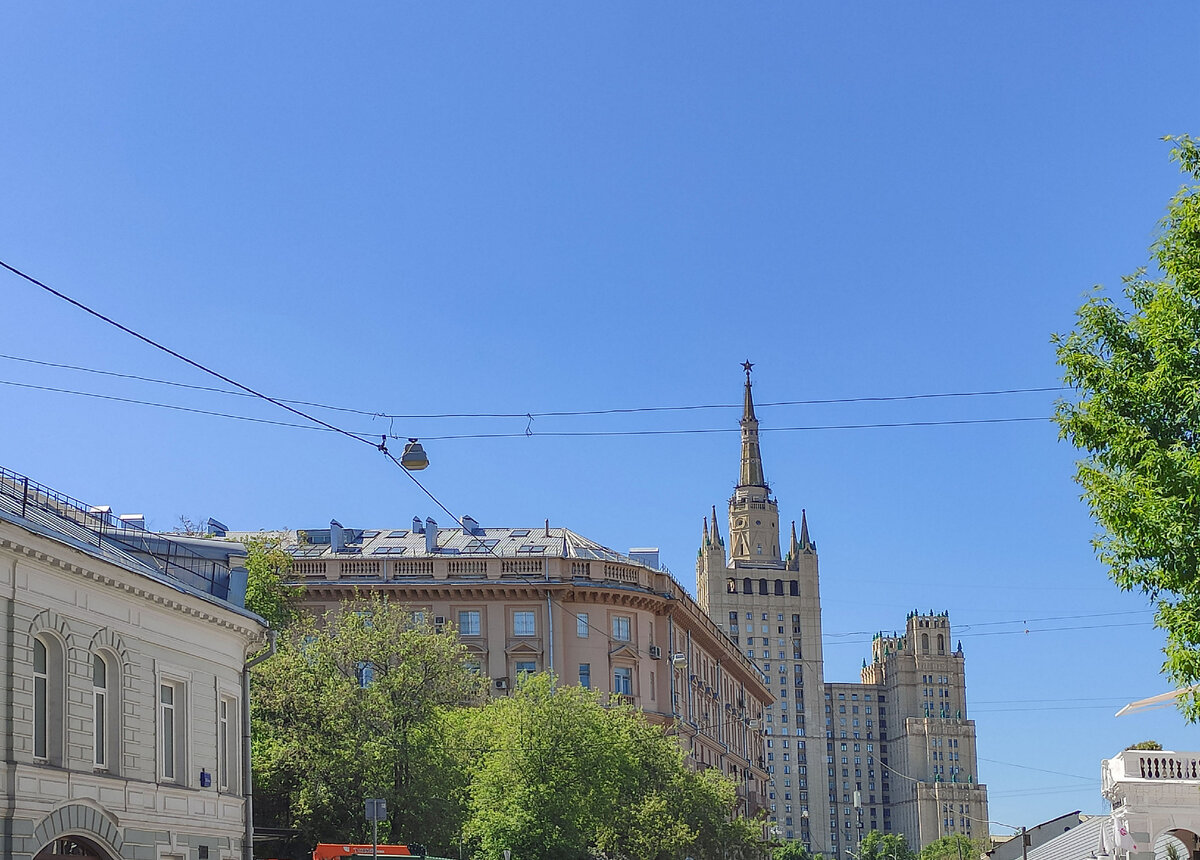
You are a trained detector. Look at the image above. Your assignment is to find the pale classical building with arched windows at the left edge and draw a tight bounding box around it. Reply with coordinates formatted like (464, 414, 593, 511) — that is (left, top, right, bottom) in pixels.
(0, 469, 265, 860)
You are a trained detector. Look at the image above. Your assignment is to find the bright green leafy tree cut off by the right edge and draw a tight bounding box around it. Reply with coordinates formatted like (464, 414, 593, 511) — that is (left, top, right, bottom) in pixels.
(1054, 137, 1200, 721)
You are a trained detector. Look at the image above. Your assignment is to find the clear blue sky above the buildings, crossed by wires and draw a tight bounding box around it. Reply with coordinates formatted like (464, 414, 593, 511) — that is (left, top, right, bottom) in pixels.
(0, 1, 1200, 832)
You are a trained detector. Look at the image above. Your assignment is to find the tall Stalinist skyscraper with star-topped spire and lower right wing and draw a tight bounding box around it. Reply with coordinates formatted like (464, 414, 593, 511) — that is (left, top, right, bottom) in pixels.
(696, 361, 988, 856)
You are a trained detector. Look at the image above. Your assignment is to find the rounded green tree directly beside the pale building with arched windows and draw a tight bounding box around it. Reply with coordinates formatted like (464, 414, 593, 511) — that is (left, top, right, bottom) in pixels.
(251, 595, 486, 854)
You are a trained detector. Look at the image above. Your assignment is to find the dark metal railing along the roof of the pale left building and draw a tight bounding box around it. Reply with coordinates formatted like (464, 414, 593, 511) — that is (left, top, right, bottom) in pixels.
(0, 467, 229, 600)
